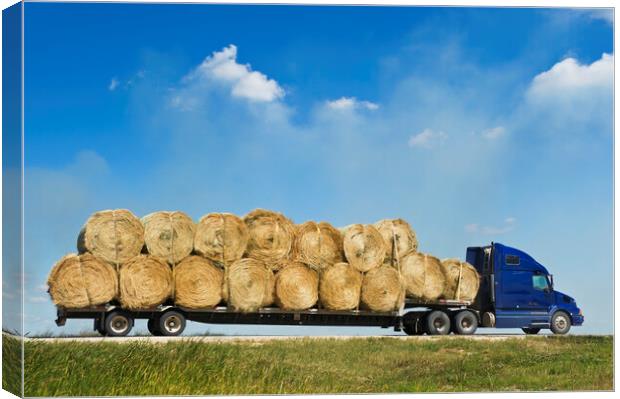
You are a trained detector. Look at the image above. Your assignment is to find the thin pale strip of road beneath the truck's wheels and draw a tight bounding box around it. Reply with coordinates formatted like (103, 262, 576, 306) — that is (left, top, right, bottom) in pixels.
(21, 334, 526, 344)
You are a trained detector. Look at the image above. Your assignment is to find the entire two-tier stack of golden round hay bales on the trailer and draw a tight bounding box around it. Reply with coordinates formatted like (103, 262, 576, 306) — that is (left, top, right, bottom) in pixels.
(48, 209, 479, 312)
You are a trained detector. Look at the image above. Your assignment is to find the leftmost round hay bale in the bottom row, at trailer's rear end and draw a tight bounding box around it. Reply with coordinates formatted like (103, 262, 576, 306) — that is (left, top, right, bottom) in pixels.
(47, 253, 118, 308)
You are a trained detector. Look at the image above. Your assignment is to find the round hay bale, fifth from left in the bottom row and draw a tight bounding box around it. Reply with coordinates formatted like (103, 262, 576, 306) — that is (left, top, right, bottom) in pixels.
(275, 262, 319, 310)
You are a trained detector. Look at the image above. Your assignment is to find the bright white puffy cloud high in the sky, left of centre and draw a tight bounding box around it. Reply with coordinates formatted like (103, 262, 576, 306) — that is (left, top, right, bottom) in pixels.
(188, 44, 285, 105)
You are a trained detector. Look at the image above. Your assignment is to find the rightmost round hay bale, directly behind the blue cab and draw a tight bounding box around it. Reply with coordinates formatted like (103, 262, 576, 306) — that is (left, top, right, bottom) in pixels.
(441, 258, 480, 301)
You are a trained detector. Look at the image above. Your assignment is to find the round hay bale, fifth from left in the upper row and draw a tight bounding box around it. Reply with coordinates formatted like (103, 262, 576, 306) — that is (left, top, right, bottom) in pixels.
(293, 222, 344, 270)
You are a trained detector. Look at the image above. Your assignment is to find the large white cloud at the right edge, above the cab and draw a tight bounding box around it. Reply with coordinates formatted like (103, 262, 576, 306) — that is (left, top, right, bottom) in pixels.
(527, 54, 614, 102)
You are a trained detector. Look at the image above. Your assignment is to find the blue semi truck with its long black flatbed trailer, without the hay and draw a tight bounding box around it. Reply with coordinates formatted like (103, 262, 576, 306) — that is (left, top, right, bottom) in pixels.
(56, 243, 584, 336)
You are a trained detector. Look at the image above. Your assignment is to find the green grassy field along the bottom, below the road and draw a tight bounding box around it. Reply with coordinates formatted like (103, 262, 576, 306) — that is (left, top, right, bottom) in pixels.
(3, 336, 613, 396)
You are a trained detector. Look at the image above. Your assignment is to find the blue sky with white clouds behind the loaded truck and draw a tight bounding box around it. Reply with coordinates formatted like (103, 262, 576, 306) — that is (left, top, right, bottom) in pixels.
(12, 3, 614, 333)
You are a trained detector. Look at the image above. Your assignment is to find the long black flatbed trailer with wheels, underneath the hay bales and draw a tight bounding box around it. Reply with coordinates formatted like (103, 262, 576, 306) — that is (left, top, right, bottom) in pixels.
(56, 299, 480, 336)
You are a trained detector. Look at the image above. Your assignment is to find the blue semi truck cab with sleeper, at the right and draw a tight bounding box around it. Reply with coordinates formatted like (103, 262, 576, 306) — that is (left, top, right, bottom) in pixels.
(467, 243, 584, 334)
